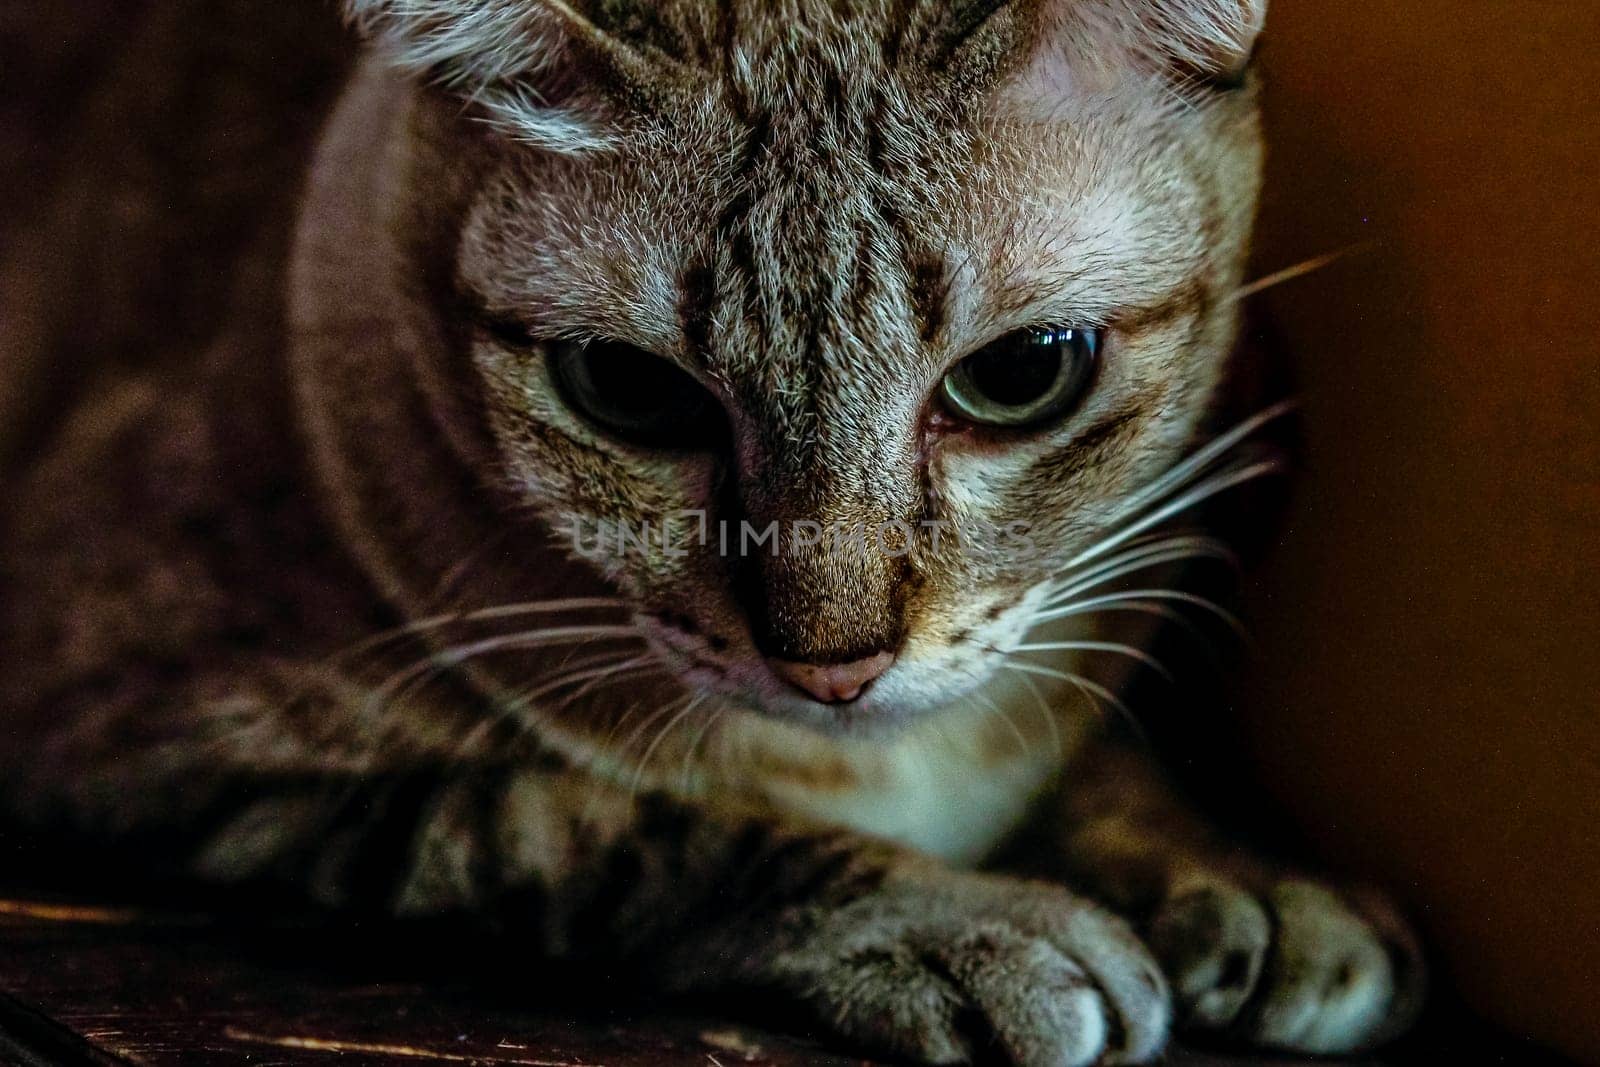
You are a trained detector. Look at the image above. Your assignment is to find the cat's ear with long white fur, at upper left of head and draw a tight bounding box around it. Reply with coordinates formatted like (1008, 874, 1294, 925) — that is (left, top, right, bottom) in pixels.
(346, 0, 664, 152)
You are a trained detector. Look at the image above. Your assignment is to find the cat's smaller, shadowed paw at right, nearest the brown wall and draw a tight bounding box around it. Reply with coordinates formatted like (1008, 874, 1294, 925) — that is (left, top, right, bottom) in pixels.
(1147, 877, 1426, 1054)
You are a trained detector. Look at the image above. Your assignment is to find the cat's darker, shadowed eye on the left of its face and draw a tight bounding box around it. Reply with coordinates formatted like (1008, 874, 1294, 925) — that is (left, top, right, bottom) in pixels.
(549, 341, 726, 448)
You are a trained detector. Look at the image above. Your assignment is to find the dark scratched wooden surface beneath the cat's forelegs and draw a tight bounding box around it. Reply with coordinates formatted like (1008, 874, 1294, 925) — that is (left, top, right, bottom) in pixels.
(0, 897, 1546, 1067)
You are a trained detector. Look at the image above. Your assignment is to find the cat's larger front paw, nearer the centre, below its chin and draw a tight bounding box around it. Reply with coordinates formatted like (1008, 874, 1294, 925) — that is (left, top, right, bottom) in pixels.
(768, 872, 1171, 1067)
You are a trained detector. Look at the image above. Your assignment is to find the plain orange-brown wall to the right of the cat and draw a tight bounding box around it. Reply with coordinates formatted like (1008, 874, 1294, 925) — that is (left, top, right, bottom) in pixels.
(1246, 0, 1600, 1061)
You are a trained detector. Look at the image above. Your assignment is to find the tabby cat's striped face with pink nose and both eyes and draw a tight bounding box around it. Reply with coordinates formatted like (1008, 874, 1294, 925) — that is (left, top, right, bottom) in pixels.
(357, 0, 1259, 729)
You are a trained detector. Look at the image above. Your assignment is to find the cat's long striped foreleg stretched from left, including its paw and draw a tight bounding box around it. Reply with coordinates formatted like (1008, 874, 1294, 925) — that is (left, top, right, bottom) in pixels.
(15, 675, 1171, 1067)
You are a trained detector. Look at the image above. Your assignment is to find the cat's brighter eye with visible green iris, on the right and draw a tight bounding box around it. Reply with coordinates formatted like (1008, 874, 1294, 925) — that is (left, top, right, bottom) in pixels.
(939, 326, 1101, 429)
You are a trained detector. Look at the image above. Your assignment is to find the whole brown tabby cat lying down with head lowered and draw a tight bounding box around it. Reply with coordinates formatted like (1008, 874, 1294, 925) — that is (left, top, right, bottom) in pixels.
(0, 0, 1422, 1065)
